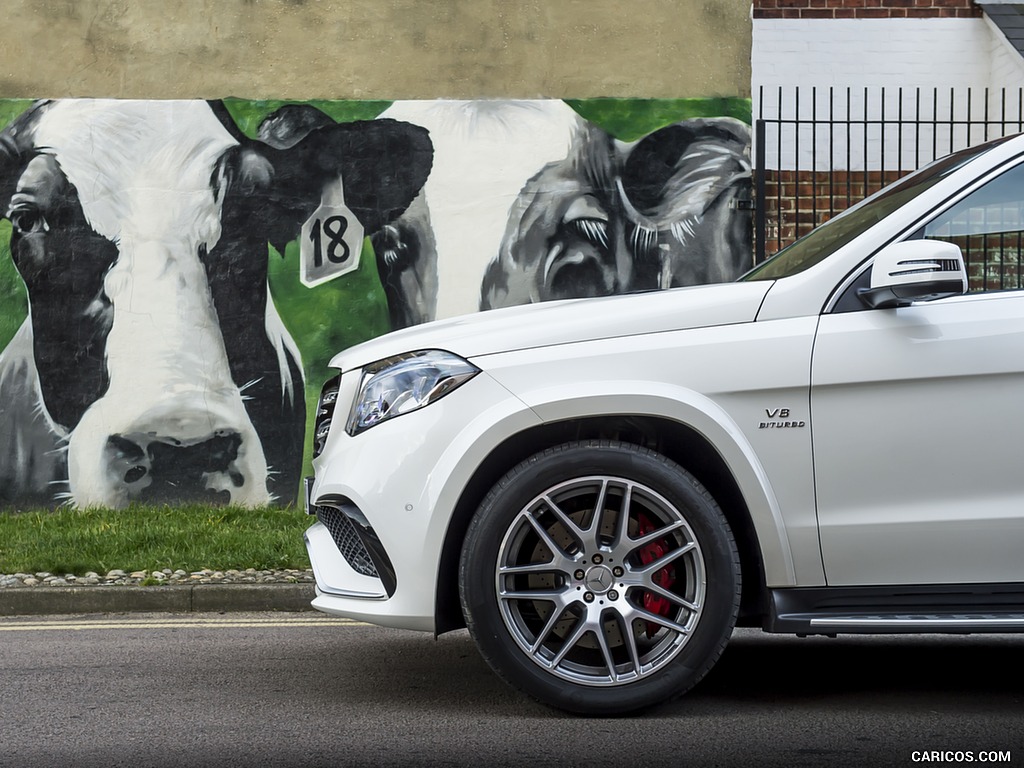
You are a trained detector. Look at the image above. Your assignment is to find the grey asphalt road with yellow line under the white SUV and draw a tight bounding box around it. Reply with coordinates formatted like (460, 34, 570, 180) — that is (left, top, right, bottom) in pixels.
(0, 612, 1024, 768)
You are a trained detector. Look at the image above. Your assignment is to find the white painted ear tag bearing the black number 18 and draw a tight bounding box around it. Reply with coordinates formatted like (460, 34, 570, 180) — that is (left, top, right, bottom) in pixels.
(299, 176, 364, 288)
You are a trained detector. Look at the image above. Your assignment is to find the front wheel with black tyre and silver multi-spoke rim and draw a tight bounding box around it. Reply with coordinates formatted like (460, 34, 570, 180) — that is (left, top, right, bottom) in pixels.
(459, 440, 740, 716)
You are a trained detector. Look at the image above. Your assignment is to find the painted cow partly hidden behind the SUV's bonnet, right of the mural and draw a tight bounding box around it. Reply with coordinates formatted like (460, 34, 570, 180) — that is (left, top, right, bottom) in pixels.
(370, 99, 753, 319)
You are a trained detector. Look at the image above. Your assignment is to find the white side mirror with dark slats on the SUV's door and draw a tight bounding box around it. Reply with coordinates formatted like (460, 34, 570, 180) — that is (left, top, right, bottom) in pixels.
(857, 240, 968, 309)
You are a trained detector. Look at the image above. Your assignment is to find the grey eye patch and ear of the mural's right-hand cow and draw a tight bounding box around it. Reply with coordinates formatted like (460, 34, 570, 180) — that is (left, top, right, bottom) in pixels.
(480, 118, 751, 309)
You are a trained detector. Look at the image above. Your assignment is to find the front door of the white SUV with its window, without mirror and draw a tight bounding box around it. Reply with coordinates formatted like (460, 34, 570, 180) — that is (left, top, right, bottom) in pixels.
(811, 160, 1024, 586)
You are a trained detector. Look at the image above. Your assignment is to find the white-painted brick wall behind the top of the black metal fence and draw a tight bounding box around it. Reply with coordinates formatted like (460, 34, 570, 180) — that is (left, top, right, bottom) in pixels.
(752, 18, 1024, 170)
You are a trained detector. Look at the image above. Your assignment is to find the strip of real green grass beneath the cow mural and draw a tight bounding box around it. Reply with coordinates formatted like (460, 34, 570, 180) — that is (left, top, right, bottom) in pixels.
(0, 504, 310, 574)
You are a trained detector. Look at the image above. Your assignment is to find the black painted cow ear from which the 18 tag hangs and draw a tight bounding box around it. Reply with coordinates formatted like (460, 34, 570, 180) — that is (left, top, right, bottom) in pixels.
(264, 119, 433, 250)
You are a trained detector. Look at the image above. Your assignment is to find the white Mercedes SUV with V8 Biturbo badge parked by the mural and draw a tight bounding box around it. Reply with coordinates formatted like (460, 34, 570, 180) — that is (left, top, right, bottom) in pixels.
(306, 136, 1024, 714)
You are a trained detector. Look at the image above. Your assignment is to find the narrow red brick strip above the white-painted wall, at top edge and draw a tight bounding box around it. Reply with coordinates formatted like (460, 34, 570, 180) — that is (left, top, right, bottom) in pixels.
(754, 0, 982, 18)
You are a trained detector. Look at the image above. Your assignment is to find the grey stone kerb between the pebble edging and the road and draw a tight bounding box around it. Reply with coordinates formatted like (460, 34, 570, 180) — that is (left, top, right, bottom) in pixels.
(0, 584, 316, 616)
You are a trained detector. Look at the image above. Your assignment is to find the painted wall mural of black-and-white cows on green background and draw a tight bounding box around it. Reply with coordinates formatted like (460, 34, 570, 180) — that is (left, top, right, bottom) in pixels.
(0, 99, 752, 508)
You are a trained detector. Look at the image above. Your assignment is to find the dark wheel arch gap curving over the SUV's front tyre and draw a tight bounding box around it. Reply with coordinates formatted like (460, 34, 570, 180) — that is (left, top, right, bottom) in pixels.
(435, 415, 767, 634)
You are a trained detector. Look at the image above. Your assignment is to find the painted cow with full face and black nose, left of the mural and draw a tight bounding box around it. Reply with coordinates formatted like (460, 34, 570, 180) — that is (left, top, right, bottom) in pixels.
(0, 99, 432, 507)
